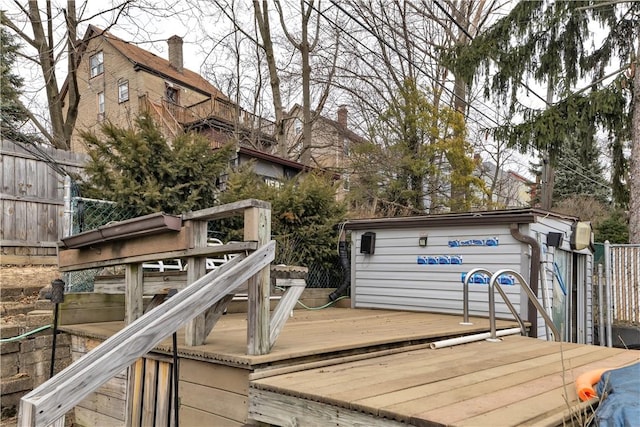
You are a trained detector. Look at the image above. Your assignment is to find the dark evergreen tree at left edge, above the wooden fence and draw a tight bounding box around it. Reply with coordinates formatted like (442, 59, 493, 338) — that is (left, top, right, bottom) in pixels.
(0, 27, 30, 142)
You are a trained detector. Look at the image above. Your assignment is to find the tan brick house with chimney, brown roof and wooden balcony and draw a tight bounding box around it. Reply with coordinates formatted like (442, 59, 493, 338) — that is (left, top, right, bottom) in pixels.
(62, 25, 304, 179)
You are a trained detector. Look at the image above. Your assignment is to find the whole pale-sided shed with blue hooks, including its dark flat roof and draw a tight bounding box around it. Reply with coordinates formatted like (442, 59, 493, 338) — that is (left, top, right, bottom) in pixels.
(346, 209, 592, 342)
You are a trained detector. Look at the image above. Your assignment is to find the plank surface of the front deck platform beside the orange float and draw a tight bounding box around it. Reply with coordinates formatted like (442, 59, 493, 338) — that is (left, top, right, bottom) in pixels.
(250, 336, 640, 426)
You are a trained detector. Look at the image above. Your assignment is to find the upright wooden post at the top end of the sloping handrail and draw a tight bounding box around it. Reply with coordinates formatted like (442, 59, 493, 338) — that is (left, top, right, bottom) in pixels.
(244, 208, 271, 355)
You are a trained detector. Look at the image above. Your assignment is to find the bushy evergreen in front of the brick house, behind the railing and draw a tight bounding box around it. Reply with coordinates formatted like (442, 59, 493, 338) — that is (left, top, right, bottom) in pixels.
(81, 115, 232, 215)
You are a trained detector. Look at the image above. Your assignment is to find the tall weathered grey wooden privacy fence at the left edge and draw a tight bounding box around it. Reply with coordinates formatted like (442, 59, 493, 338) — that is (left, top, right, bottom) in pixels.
(0, 140, 87, 265)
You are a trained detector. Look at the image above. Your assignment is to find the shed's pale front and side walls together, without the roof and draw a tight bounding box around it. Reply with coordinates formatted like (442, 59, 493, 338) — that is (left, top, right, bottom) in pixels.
(352, 217, 593, 343)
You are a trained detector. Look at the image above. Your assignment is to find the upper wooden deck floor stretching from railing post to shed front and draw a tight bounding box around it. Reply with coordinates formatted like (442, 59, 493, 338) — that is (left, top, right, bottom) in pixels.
(61, 308, 518, 370)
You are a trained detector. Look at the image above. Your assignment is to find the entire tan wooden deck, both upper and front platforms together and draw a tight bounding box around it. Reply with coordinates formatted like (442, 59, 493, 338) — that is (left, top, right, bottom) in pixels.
(63, 308, 640, 426)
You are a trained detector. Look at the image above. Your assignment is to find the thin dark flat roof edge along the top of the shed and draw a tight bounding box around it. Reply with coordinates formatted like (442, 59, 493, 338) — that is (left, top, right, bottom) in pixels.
(345, 208, 579, 230)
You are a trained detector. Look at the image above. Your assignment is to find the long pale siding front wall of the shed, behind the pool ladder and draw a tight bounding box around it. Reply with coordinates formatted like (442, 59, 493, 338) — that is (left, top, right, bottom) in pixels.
(352, 226, 529, 318)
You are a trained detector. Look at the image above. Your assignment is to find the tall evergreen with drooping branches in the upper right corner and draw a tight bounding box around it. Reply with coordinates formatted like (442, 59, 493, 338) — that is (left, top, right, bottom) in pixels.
(452, 0, 640, 239)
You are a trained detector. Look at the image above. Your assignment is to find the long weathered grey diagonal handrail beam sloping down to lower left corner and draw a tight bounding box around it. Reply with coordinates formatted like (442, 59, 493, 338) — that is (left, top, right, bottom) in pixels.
(18, 242, 275, 426)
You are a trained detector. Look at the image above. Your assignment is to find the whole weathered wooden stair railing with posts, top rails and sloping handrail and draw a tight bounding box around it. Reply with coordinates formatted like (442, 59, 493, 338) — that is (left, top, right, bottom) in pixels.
(18, 199, 299, 426)
